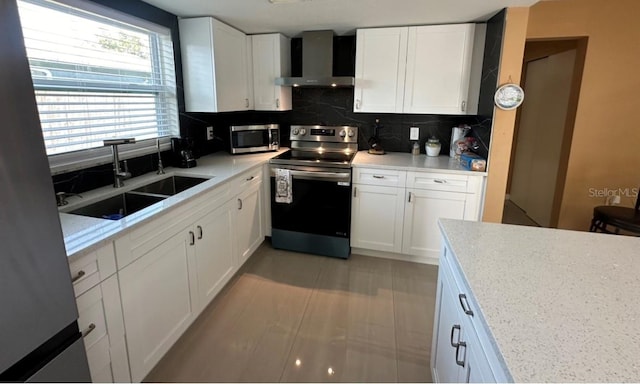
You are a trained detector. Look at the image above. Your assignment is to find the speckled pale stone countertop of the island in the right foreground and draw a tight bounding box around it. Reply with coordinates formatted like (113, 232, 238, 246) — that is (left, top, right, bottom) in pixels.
(439, 219, 640, 382)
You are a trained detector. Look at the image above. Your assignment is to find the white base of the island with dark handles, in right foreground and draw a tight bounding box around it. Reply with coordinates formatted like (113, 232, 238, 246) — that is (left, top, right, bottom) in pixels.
(431, 246, 507, 383)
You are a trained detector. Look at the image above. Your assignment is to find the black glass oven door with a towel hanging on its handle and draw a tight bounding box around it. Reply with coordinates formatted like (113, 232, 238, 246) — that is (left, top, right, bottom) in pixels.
(270, 165, 351, 239)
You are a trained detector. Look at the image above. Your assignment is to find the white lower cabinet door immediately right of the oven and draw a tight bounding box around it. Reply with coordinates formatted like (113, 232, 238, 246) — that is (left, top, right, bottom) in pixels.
(351, 184, 405, 253)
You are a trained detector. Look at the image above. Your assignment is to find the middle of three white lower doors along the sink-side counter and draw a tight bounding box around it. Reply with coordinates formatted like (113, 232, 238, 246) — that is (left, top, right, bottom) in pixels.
(193, 201, 235, 310)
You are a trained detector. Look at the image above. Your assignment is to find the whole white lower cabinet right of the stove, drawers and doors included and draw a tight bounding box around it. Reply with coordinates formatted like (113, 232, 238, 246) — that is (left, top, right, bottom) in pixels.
(351, 168, 484, 262)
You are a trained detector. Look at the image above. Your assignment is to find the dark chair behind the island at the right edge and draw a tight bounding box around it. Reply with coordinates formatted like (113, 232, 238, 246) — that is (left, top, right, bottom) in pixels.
(589, 193, 640, 236)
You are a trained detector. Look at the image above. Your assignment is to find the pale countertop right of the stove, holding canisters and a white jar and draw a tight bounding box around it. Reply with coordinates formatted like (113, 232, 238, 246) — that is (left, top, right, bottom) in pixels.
(351, 151, 487, 176)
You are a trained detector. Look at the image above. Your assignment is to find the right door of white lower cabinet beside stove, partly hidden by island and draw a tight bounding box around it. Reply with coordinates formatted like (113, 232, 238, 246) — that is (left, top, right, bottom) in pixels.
(402, 188, 467, 259)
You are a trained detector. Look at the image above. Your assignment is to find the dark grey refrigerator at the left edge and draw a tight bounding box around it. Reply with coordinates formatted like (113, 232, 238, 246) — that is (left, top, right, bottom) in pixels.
(0, 0, 91, 382)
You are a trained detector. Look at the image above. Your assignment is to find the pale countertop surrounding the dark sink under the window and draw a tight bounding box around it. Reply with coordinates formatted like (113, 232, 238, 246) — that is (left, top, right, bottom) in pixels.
(58, 148, 288, 260)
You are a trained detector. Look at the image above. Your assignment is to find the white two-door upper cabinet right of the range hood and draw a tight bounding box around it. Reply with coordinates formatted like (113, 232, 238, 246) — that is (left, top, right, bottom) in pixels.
(354, 24, 485, 115)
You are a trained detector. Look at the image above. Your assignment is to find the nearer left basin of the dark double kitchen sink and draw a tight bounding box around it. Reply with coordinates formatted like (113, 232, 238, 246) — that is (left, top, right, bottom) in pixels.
(69, 192, 167, 220)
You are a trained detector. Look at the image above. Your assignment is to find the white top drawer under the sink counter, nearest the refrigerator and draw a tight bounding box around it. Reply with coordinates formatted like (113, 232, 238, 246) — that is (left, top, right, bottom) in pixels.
(69, 243, 116, 297)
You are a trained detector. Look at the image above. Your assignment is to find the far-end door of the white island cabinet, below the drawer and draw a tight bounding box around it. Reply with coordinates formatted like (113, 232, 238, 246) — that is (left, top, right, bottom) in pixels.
(431, 254, 464, 383)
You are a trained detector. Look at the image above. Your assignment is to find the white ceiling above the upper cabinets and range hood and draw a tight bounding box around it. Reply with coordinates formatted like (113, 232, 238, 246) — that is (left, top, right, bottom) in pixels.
(143, 0, 538, 37)
